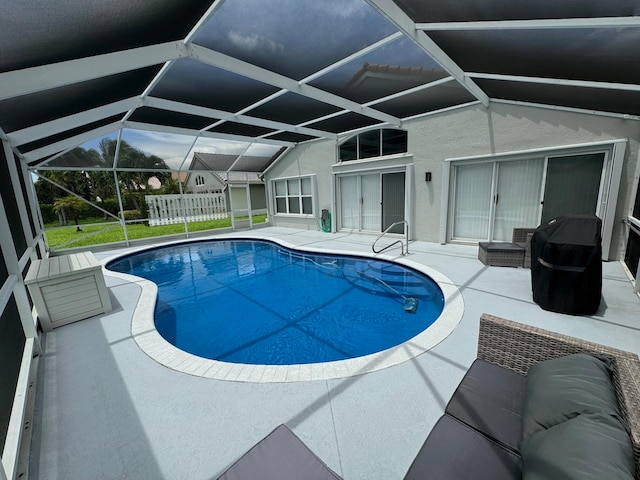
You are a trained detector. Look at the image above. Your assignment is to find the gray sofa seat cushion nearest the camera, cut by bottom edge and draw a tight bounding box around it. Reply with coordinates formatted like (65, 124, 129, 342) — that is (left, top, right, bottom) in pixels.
(404, 414, 522, 480)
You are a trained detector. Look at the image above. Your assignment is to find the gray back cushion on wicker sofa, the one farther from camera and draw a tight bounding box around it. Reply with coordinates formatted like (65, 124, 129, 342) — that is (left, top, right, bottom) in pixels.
(522, 354, 620, 441)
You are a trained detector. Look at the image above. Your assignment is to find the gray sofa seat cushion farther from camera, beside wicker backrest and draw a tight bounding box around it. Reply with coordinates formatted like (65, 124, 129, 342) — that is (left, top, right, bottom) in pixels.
(445, 359, 527, 452)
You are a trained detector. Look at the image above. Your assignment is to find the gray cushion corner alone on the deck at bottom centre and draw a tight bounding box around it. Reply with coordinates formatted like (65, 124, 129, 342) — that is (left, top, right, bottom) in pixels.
(219, 425, 340, 480)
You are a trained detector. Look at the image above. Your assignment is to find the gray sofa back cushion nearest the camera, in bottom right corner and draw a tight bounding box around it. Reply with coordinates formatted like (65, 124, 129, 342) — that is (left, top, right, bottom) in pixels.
(520, 413, 635, 480)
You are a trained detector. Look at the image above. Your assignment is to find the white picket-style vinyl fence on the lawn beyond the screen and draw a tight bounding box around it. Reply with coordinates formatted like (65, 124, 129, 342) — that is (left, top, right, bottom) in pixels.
(145, 193, 228, 226)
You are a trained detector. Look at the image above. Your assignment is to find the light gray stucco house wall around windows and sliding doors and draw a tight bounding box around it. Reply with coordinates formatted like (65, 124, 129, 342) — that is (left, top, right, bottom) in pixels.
(265, 103, 640, 259)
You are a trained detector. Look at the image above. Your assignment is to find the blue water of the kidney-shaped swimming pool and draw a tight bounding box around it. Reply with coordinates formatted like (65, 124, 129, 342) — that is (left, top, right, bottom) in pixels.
(107, 240, 444, 365)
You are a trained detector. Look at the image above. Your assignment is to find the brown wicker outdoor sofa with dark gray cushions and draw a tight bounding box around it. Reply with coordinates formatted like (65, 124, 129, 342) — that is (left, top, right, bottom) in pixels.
(405, 314, 640, 480)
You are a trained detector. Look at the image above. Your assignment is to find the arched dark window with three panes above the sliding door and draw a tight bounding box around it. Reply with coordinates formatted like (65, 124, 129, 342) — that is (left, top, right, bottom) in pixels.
(340, 128, 407, 162)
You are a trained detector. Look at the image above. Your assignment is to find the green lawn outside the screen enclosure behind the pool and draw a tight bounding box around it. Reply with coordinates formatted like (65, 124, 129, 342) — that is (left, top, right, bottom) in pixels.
(45, 215, 267, 249)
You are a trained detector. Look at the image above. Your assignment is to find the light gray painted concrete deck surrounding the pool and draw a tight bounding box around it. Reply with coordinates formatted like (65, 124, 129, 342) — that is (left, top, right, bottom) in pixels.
(29, 227, 640, 480)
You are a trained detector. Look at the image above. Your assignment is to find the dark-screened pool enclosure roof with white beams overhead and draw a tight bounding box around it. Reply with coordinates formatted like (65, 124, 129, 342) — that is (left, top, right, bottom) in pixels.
(0, 0, 640, 170)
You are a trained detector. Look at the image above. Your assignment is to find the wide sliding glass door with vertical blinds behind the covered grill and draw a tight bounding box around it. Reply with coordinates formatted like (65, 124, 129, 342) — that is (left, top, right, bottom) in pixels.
(450, 152, 605, 241)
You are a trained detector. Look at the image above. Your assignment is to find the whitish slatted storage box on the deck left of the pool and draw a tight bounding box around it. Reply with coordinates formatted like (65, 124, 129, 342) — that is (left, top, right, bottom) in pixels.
(24, 252, 111, 331)
